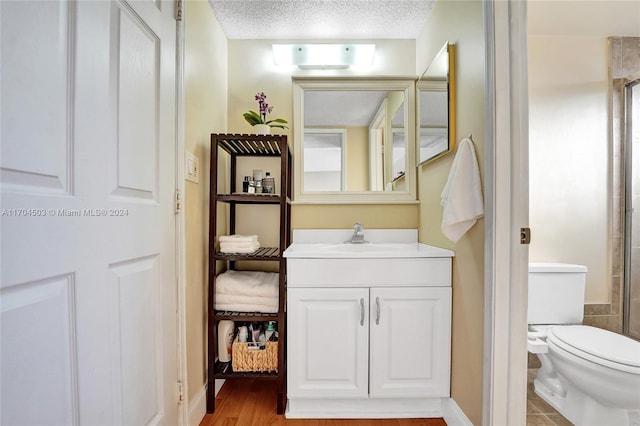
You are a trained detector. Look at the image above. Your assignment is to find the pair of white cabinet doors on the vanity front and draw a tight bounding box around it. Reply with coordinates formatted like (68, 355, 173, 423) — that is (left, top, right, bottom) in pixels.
(287, 287, 451, 398)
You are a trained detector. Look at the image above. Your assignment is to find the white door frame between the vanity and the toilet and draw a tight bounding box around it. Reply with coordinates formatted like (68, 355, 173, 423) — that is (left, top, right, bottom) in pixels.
(482, 0, 529, 425)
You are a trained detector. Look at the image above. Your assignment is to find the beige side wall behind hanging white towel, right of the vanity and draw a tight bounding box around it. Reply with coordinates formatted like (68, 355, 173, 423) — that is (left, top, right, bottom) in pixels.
(416, 0, 485, 425)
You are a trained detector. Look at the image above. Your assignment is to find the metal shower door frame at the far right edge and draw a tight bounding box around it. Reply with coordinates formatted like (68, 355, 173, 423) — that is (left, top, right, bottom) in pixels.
(622, 72, 640, 339)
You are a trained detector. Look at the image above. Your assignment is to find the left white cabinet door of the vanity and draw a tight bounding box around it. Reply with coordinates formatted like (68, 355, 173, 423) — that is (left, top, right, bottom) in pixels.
(287, 288, 369, 398)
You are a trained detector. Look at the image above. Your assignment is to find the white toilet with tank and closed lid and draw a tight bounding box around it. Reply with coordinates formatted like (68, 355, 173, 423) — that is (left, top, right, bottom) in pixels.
(527, 263, 640, 426)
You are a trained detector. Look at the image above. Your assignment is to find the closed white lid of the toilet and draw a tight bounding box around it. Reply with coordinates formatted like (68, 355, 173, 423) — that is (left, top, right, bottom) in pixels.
(547, 325, 640, 368)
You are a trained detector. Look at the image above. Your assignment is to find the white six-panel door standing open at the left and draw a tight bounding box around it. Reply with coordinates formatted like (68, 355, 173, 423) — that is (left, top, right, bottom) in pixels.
(0, 0, 178, 425)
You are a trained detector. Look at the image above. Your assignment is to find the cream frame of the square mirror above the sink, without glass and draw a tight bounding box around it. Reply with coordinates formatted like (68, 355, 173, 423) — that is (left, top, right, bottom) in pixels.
(292, 77, 418, 204)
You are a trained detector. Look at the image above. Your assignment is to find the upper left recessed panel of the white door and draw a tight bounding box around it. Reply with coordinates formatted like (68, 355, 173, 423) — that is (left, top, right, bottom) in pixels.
(0, 1, 76, 195)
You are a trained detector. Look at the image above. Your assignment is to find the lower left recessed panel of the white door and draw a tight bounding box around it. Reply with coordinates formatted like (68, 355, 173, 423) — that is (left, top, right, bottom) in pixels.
(0, 274, 78, 425)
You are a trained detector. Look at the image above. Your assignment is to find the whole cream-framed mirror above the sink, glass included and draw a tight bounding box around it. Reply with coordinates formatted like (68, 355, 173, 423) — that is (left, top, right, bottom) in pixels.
(293, 77, 416, 204)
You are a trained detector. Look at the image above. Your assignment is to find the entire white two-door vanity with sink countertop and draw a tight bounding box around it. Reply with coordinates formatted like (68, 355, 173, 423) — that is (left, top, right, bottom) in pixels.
(284, 231, 453, 418)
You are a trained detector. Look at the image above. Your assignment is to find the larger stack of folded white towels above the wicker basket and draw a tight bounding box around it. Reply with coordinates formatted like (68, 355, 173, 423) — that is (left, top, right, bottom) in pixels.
(214, 271, 278, 313)
